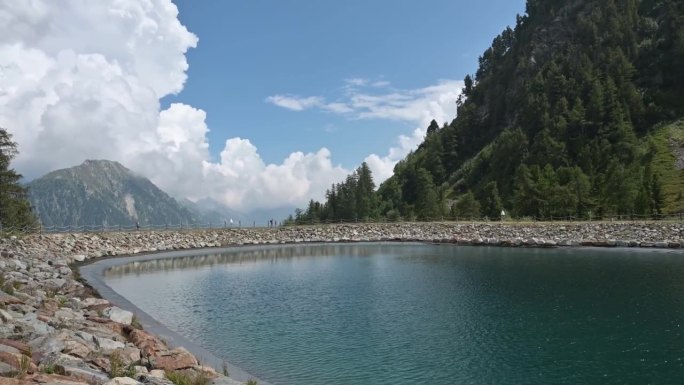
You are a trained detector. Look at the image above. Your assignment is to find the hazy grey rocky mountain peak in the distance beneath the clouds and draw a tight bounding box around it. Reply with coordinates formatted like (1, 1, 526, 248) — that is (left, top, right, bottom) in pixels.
(26, 160, 202, 226)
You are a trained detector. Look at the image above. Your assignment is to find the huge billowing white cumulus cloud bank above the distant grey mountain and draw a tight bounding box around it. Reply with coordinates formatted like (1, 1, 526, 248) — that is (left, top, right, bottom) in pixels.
(0, 0, 347, 210)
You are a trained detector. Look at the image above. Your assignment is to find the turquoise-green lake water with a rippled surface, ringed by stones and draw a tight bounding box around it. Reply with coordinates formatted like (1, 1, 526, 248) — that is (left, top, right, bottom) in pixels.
(106, 244, 684, 385)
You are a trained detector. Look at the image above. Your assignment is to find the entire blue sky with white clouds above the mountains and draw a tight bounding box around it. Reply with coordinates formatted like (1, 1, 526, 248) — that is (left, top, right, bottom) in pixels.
(0, 0, 525, 212)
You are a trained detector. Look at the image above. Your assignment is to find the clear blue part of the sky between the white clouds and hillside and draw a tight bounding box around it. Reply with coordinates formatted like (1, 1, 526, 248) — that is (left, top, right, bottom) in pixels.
(163, 0, 525, 169)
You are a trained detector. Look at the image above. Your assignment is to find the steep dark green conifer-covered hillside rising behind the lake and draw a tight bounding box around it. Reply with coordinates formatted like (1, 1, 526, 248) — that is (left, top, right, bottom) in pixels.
(290, 0, 684, 220)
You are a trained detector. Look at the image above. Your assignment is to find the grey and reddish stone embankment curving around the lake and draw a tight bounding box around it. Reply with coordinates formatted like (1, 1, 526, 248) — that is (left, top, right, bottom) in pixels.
(0, 223, 684, 385)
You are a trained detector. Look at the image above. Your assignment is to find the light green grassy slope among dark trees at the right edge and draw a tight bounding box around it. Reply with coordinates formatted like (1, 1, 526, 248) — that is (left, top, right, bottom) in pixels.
(651, 119, 684, 214)
